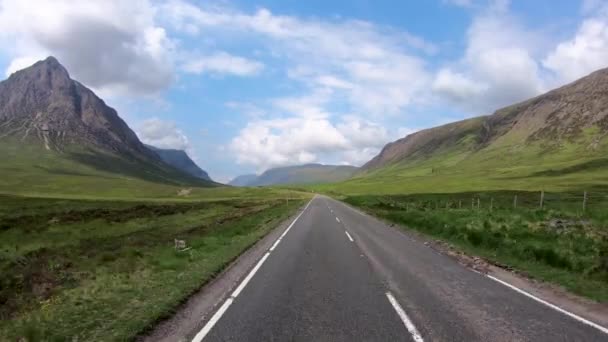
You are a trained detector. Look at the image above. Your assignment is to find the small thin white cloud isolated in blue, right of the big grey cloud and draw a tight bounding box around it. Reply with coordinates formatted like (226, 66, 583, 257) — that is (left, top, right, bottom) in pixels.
(183, 51, 264, 76)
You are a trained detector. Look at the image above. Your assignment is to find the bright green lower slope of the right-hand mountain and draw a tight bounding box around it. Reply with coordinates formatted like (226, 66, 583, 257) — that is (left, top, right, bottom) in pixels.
(313, 129, 608, 195)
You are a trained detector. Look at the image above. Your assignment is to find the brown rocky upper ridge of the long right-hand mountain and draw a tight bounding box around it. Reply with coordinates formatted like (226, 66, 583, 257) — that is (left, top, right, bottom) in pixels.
(359, 69, 608, 174)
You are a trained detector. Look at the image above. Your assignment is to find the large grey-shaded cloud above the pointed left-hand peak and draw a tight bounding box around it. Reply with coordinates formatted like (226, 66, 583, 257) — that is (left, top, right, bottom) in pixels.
(0, 0, 174, 94)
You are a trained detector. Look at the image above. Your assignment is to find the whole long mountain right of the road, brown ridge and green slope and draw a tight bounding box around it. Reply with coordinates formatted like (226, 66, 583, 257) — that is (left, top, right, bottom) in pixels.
(350, 69, 608, 195)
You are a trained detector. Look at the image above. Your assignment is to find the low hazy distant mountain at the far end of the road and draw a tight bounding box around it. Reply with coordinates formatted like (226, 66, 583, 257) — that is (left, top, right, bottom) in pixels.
(231, 164, 357, 186)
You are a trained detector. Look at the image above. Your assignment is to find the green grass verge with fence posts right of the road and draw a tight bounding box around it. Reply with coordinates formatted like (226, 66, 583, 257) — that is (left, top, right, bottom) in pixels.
(344, 192, 608, 302)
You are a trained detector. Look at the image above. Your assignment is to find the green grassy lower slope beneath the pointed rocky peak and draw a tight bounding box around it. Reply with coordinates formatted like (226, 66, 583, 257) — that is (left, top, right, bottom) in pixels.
(0, 138, 215, 198)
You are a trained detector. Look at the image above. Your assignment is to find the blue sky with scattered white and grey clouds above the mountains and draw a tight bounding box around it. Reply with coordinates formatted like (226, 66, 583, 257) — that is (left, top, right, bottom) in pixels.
(0, 0, 608, 182)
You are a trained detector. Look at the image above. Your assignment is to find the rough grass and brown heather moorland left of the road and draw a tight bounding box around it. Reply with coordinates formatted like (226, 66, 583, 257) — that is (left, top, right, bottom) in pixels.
(0, 194, 304, 341)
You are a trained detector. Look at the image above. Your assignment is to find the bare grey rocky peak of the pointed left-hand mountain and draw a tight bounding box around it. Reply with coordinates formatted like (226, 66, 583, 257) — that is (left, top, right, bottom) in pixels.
(0, 56, 154, 160)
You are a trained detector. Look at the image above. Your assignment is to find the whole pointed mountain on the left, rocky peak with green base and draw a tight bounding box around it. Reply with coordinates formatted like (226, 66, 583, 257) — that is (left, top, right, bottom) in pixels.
(0, 57, 215, 192)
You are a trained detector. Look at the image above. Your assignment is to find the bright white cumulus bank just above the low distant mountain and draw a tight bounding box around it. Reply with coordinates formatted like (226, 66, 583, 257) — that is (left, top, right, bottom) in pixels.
(230, 117, 388, 171)
